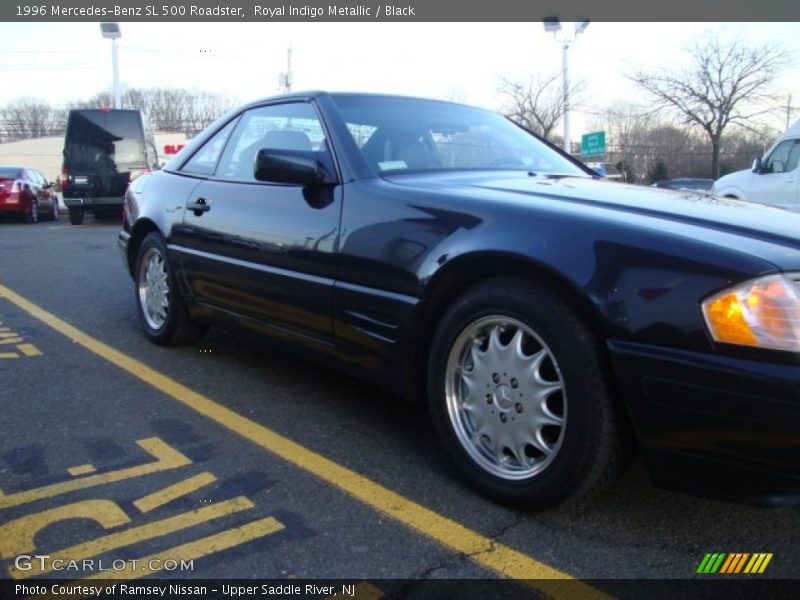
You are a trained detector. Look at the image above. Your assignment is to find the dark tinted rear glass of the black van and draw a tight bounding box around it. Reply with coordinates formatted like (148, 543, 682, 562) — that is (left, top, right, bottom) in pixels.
(65, 110, 147, 171)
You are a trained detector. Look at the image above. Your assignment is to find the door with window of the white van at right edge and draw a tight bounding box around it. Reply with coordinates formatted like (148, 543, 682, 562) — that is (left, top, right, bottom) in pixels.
(747, 139, 800, 210)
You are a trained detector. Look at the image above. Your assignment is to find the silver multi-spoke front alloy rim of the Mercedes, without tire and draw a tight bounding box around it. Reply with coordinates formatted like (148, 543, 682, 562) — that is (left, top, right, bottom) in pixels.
(445, 315, 567, 481)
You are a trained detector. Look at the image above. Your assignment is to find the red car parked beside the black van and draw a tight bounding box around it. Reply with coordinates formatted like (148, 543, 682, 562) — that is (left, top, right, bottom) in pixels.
(0, 166, 58, 223)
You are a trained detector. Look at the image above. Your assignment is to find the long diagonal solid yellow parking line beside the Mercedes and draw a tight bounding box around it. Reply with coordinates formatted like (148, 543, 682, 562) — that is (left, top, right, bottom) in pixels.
(0, 285, 608, 598)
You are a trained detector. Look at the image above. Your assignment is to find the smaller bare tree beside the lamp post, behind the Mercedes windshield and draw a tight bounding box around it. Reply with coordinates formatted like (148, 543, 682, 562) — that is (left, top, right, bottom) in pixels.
(497, 73, 585, 141)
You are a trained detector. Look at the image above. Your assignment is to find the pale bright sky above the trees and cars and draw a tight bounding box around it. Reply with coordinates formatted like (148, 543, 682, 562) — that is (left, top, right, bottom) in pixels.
(0, 22, 800, 139)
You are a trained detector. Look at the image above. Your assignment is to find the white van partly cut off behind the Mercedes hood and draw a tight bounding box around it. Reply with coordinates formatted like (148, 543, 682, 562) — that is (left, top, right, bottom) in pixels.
(712, 121, 800, 211)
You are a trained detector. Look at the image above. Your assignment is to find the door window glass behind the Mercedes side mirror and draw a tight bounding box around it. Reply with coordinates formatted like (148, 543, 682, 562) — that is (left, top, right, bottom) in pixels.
(217, 102, 327, 181)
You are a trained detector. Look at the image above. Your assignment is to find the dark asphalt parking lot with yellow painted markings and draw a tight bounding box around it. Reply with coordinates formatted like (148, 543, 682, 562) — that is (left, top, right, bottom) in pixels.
(0, 219, 800, 597)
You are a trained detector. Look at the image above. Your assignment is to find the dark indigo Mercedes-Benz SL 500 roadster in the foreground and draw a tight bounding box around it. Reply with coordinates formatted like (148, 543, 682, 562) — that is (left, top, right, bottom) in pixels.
(119, 92, 800, 508)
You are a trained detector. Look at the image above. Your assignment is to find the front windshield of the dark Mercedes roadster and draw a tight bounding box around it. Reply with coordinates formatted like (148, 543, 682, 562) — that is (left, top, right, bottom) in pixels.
(333, 95, 589, 177)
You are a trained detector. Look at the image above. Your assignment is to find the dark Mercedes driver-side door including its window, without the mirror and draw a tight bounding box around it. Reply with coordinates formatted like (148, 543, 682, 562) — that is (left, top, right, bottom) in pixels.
(175, 102, 341, 342)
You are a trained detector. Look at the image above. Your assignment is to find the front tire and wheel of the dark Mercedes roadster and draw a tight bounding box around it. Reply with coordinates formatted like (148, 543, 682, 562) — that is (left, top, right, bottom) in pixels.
(428, 278, 622, 509)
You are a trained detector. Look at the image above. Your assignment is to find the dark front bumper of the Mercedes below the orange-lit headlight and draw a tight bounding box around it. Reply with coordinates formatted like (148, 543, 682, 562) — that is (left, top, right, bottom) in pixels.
(608, 341, 800, 504)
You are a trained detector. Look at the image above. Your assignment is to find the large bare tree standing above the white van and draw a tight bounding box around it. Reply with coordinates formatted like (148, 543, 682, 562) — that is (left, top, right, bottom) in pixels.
(630, 38, 787, 178)
